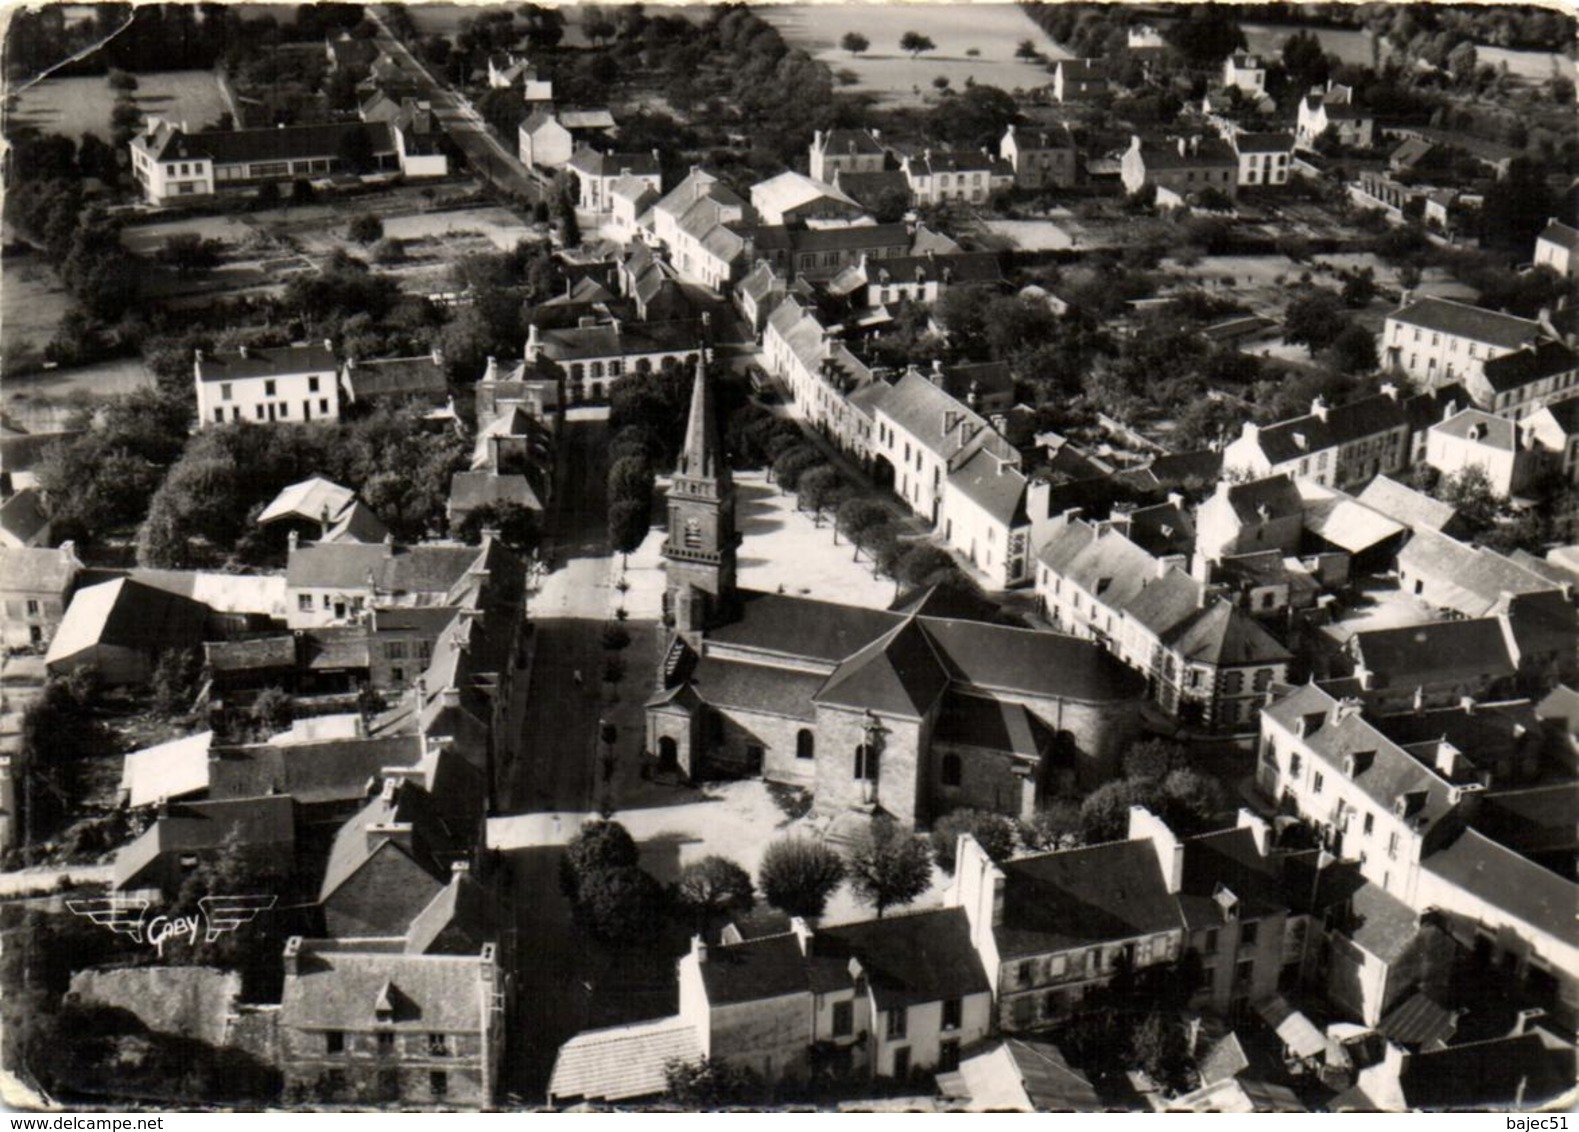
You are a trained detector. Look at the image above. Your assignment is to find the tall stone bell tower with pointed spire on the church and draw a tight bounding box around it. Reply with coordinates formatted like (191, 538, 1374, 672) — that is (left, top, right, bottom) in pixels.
(663, 352, 739, 647)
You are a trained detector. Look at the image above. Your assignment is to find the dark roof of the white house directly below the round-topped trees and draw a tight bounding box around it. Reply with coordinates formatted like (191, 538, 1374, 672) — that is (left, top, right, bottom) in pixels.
(814, 908, 992, 1010)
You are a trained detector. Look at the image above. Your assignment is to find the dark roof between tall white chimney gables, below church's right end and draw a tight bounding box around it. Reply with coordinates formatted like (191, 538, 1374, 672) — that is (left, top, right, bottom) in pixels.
(993, 840, 1183, 960)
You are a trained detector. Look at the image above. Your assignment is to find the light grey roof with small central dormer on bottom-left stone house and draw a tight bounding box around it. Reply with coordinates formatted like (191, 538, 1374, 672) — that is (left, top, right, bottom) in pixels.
(279, 939, 485, 1034)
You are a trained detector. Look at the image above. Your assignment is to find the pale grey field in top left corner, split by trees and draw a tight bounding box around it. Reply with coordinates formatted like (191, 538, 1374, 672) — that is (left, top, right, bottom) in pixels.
(5, 71, 227, 141)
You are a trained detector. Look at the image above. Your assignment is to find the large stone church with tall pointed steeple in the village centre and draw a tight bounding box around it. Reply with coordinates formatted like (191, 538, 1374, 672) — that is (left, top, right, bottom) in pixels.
(646, 363, 1145, 826)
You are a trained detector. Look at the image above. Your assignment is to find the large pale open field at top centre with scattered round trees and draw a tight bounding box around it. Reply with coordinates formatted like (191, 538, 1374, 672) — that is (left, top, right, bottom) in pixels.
(756, 3, 1069, 103)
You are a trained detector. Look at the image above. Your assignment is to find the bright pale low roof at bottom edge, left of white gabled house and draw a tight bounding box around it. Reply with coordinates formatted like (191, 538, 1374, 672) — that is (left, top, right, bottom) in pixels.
(548, 1018, 701, 1104)
